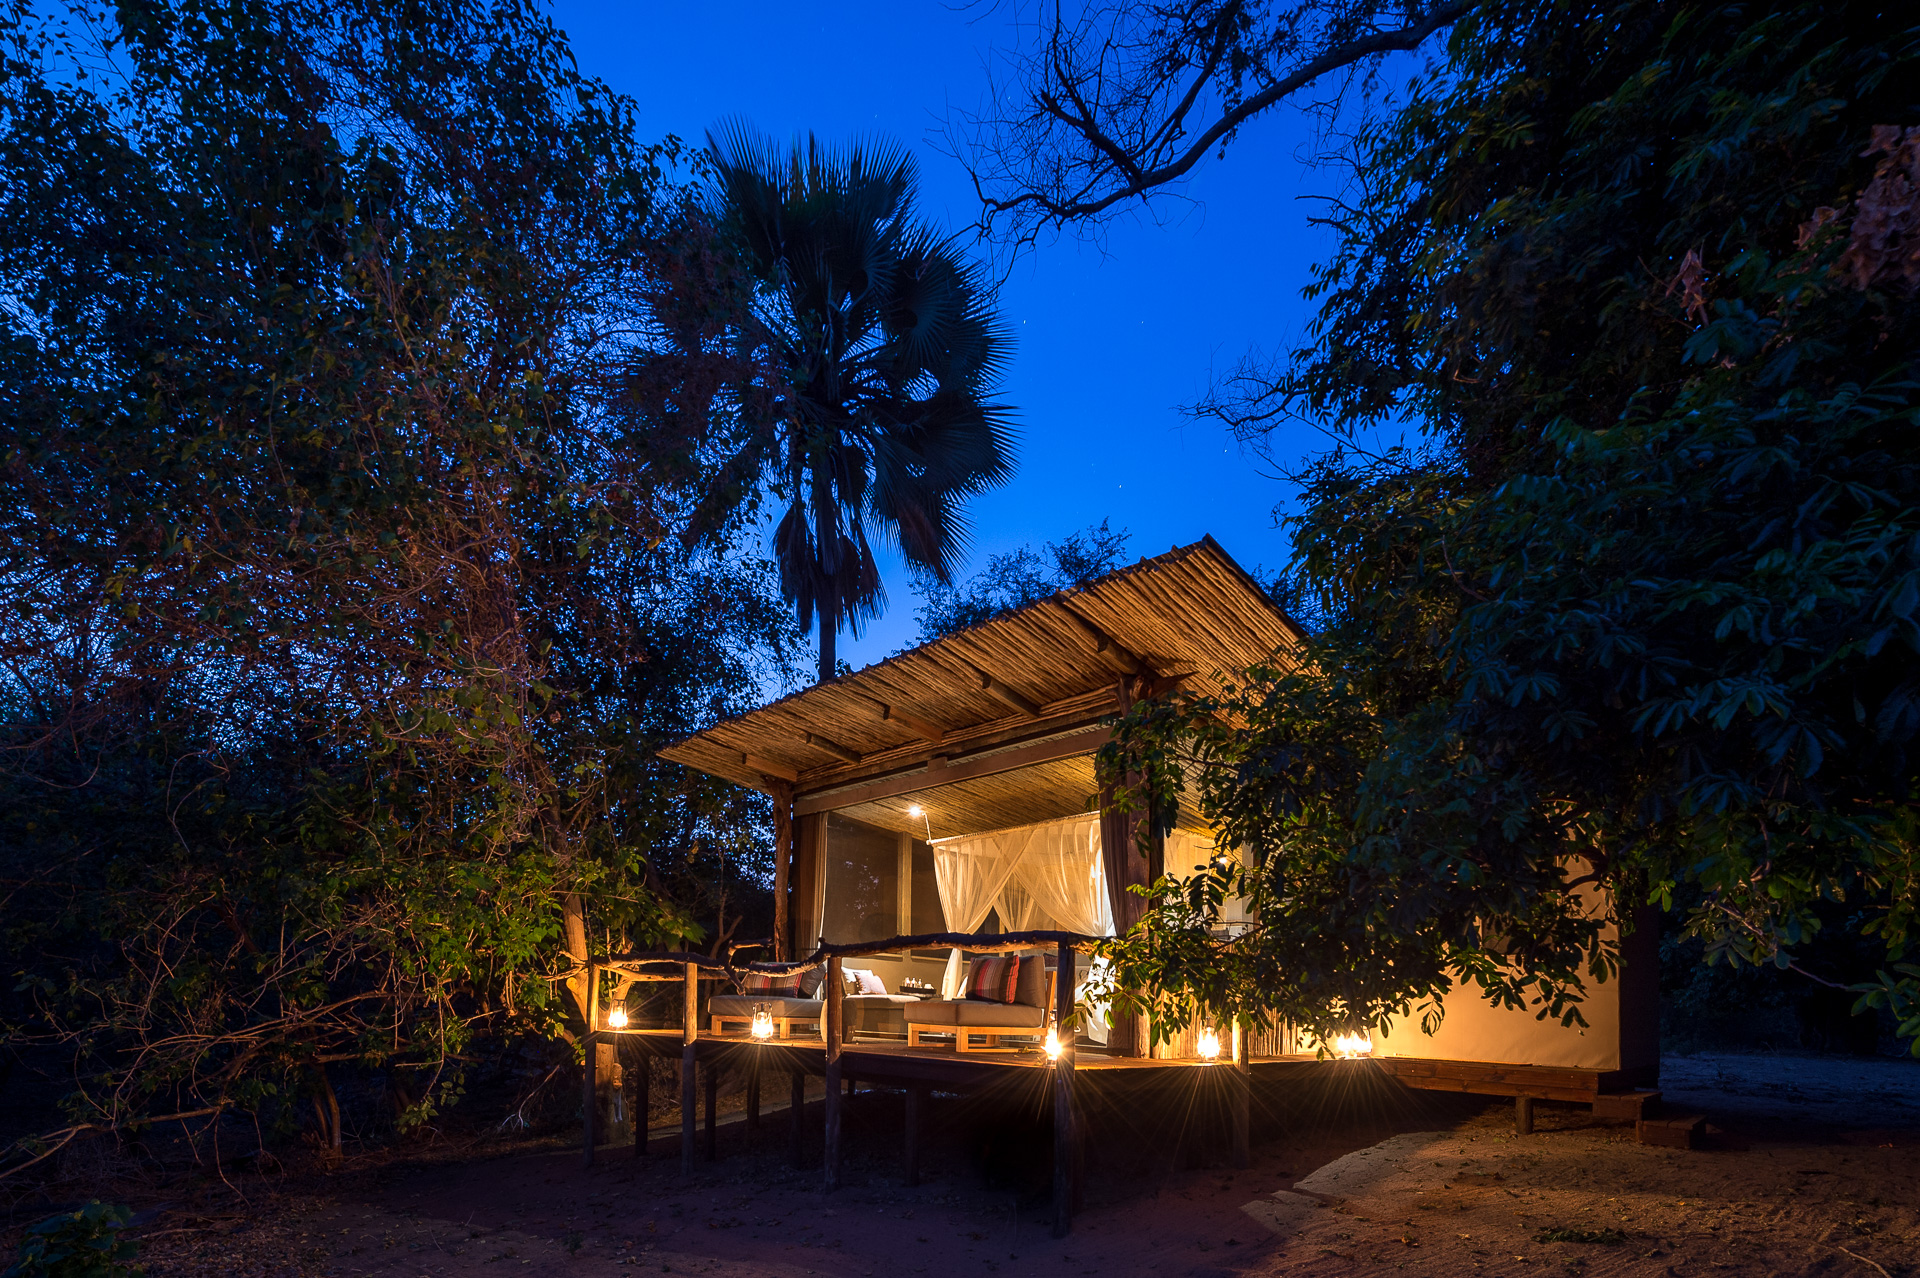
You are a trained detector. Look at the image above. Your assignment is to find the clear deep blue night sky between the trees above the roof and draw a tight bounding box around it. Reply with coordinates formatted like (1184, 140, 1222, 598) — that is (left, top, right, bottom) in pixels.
(553, 0, 1338, 668)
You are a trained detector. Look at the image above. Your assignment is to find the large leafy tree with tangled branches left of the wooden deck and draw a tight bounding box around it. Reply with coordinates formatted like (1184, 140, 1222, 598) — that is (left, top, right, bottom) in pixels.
(0, 0, 795, 1148)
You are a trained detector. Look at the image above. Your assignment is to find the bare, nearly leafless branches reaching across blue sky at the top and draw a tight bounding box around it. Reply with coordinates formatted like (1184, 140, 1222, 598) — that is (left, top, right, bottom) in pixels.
(948, 0, 1475, 244)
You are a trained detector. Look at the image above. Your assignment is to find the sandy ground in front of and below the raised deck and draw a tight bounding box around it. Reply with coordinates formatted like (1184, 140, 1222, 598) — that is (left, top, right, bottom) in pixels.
(82, 1055, 1920, 1278)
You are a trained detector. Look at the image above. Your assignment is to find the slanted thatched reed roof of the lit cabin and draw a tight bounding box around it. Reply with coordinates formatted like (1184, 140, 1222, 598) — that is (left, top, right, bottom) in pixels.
(660, 537, 1300, 806)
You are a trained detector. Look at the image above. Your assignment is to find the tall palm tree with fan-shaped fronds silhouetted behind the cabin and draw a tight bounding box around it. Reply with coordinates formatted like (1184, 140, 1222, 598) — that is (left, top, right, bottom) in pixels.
(707, 127, 1014, 679)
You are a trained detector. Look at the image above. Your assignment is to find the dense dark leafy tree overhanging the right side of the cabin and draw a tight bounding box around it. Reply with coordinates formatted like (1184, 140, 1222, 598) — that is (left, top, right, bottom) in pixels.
(1108, 0, 1920, 1044)
